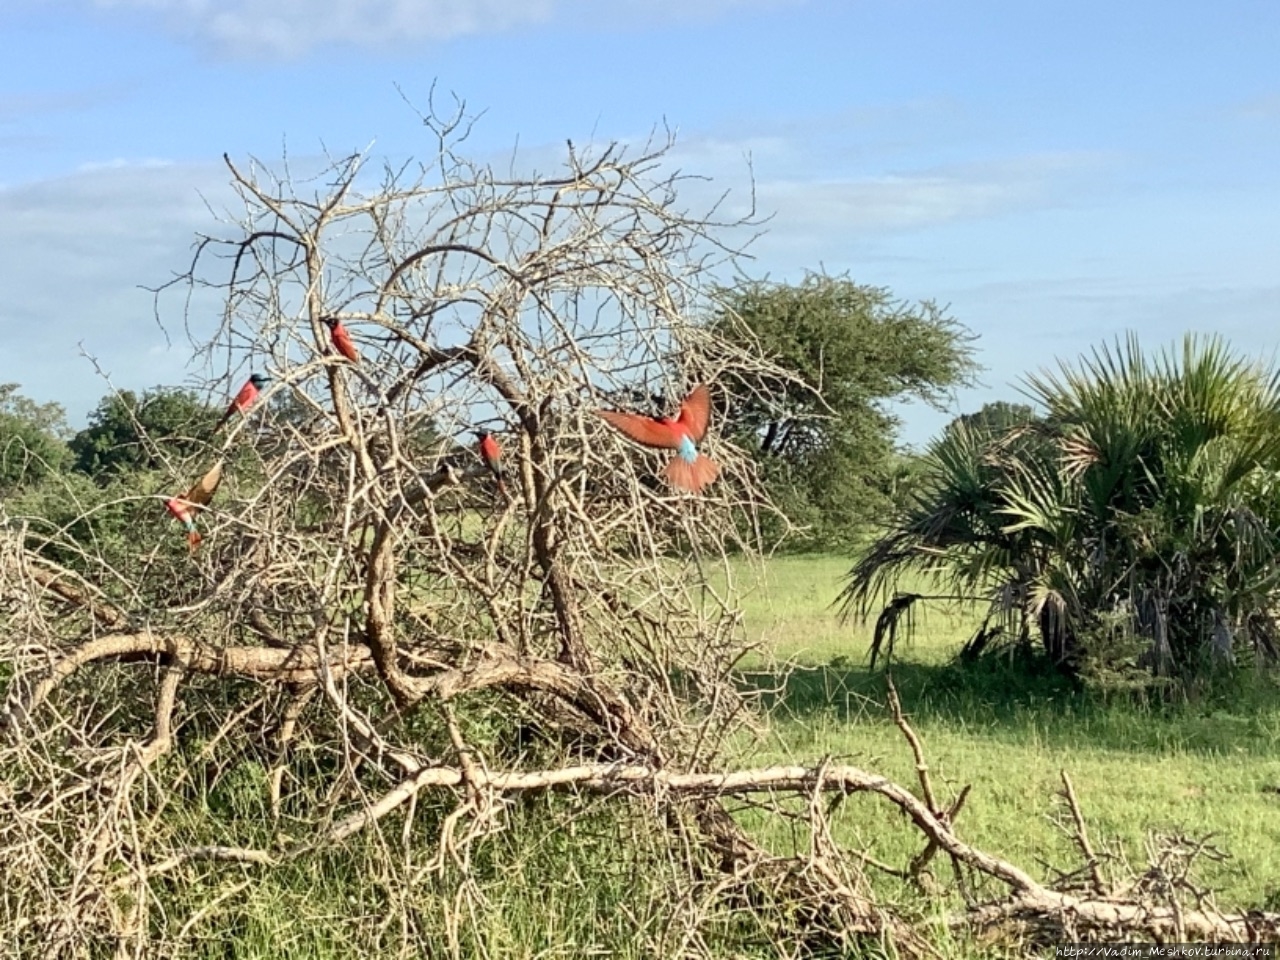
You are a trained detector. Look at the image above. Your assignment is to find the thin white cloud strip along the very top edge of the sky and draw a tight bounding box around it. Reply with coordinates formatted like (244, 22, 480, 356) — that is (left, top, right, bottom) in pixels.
(78, 0, 797, 58)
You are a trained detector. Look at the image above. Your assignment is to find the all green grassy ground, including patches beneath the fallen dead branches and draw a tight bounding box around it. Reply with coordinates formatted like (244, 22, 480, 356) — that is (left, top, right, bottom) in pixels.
(27, 557, 1280, 960)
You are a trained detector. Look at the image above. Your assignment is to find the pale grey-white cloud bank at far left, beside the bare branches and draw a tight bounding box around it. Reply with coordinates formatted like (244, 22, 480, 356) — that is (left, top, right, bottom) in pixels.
(0, 161, 227, 420)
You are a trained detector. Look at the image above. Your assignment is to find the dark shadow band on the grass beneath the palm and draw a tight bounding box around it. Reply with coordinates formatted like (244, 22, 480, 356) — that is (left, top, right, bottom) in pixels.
(744, 655, 1280, 759)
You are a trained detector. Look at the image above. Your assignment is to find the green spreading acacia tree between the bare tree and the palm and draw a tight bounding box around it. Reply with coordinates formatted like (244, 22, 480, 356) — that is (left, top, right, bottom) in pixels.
(710, 274, 977, 548)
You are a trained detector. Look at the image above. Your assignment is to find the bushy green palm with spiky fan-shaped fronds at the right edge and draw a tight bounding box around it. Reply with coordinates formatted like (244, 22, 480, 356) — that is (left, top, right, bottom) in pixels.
(842, 335, 1280, 673)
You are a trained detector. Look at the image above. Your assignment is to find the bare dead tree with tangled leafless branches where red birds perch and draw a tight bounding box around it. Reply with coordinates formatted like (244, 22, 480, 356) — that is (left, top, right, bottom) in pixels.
(0, 106, 1274, 956)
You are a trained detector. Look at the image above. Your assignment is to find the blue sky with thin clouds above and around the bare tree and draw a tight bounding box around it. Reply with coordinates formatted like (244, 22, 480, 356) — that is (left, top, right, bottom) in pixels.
(0, 0, 1280, 444)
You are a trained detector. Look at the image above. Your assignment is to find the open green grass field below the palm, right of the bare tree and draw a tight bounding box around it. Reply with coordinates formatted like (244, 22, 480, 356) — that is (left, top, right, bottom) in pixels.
(727, 557, 1280, 909)
